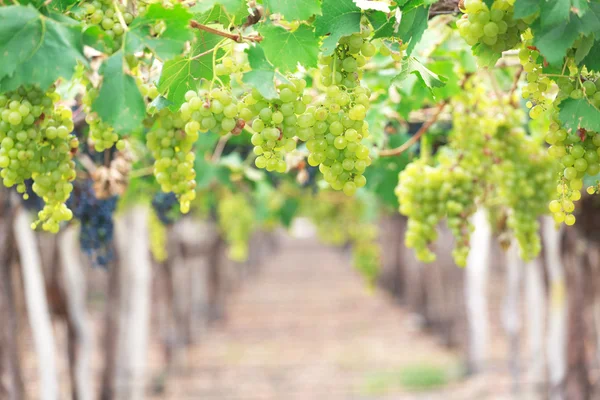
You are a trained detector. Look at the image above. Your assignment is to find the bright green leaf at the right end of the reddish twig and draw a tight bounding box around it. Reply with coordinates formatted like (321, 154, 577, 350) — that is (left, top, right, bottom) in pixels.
(259, 24, 319, 72)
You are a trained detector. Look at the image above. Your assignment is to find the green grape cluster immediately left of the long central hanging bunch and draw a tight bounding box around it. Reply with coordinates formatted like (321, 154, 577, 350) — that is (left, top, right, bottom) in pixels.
(244, 79, 313, 173)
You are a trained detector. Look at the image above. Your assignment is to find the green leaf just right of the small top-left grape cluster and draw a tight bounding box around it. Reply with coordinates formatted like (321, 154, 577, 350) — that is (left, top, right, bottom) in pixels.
(125, 3, 193, 60)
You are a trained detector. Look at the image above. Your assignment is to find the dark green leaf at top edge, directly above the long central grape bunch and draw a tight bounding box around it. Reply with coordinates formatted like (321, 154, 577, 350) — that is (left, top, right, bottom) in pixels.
(315, 0, 361, 56)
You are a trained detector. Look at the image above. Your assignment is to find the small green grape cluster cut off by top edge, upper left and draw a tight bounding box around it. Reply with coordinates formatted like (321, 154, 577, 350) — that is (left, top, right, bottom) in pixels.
(76, 0, 133, 39)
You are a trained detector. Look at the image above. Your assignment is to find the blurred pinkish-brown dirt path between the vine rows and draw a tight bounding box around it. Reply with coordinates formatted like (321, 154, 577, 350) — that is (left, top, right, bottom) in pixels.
(160, 239, 460, 400)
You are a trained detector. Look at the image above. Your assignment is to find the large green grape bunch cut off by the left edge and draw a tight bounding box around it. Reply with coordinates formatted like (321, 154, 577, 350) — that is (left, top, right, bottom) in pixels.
(0, 86, 78, 232)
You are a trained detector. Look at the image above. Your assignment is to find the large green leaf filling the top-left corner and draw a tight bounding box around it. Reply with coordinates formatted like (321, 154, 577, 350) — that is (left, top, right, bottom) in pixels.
(0, 6, 87, 91)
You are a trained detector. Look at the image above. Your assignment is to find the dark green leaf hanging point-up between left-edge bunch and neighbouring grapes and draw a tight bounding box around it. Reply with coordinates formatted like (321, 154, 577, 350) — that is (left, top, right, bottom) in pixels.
(92, 51, 146, 133)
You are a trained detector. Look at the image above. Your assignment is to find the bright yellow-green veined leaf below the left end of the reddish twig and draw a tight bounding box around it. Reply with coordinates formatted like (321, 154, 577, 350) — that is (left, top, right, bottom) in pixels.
(158, 31, 222, 107)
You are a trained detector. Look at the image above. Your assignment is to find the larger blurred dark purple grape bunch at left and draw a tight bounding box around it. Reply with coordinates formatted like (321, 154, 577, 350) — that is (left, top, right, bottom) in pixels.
(68, 179, 118, 267)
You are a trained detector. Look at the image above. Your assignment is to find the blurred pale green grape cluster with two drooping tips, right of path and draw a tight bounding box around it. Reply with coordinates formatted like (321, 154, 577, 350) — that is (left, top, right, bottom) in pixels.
(395, 161, 477, 266)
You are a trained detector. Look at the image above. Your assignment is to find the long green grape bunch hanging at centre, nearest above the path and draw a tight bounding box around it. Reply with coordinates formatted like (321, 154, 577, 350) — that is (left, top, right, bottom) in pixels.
(308, 25, 376, 196)
